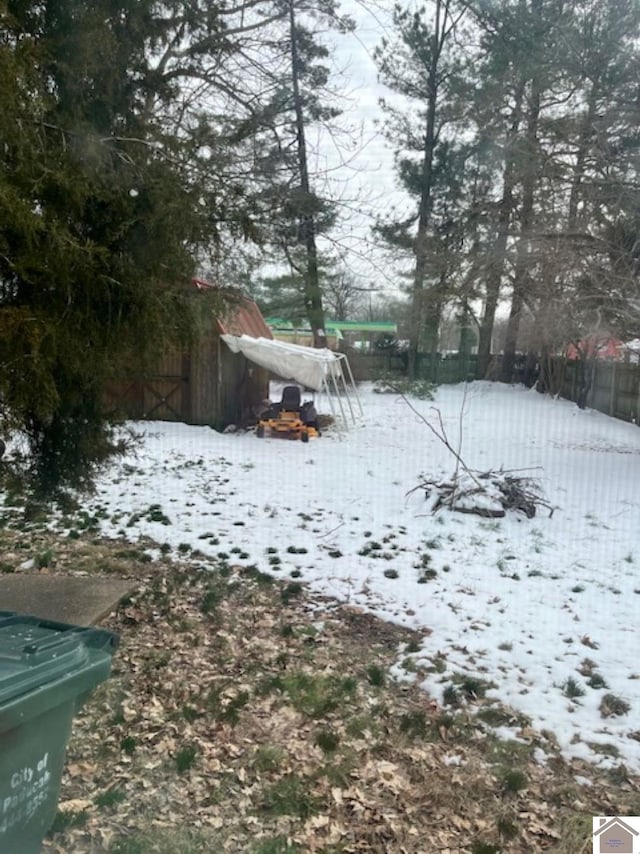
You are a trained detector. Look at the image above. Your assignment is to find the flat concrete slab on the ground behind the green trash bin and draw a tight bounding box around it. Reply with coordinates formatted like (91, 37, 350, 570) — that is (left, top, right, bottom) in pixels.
(0, 573, 136, 626)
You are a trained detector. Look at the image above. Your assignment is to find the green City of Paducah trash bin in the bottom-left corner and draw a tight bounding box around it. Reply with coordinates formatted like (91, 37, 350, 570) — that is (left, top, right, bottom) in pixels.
(0, 611, 118, 854)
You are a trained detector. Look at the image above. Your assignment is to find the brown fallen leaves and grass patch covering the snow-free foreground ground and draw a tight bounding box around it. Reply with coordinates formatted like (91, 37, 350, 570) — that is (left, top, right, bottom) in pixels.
(0, 530, 640, 854)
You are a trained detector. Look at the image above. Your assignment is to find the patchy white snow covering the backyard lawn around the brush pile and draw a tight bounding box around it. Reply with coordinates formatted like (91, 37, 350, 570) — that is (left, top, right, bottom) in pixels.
(82, 382, 640, 772)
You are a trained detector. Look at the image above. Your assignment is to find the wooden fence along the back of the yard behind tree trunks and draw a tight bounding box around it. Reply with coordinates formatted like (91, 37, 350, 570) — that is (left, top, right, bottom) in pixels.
(349, 352, 640, 424)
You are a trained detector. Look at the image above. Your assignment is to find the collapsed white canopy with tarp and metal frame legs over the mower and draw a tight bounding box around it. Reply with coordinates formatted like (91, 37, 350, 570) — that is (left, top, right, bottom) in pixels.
(221, 335, 362, 421)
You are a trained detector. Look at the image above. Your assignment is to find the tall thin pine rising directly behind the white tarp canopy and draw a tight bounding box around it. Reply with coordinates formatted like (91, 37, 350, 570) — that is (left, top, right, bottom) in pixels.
(246, 0, 352, 347)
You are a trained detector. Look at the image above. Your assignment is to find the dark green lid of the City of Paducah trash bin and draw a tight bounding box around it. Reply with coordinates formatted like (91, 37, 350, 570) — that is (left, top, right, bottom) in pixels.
(0, 612, 110, 709)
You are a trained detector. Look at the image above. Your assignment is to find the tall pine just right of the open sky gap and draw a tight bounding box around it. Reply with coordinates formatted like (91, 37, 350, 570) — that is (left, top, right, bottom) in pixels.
(376, 0, 464, 376)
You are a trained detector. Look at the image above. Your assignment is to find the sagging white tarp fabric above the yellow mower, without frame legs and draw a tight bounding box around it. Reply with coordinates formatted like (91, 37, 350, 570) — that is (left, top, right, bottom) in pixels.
(222, 335, 342, 391)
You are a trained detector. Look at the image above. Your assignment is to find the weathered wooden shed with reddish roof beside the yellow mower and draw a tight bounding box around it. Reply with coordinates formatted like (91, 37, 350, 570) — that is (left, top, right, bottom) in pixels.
(106, 290, 273, 429)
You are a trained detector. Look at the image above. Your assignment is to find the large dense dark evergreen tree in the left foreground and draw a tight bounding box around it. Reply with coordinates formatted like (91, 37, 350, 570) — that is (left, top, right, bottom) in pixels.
(0, 0, 235, 491)
